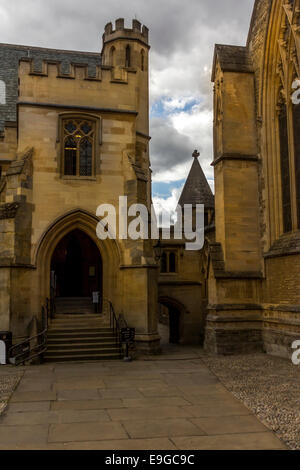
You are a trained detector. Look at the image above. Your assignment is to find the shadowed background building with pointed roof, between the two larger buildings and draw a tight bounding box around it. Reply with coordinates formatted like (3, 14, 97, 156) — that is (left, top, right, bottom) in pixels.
(158, 152, 215, 344)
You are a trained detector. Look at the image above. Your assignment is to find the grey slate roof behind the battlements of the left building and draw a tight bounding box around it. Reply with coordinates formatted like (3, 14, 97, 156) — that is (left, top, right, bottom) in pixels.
(0, 44, 101, 133)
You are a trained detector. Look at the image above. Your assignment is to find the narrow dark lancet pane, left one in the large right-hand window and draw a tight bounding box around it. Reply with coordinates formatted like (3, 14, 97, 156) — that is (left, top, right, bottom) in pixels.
(278, 103, 292, 233)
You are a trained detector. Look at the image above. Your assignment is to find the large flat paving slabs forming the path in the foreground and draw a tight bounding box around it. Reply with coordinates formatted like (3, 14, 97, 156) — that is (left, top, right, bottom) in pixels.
(0, 356, 286, 450)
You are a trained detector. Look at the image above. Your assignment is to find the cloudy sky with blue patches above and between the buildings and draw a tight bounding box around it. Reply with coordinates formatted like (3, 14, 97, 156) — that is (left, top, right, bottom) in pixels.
(0, 0, 254, 212)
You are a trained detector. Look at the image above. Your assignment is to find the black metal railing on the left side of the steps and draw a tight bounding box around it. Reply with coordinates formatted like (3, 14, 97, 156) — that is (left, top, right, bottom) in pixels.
(8, 299, 49, 366)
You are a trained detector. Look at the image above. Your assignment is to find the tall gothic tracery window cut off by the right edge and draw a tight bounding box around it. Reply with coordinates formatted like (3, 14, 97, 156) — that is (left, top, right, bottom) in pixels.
(265, 0, 300, 236)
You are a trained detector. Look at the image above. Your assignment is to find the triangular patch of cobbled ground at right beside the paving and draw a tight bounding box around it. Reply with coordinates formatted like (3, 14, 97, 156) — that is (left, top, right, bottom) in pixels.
(201, 354, 300, 450)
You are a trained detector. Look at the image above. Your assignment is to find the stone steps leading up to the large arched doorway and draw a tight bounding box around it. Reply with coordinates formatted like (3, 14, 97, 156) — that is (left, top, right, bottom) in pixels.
(44, 313, 121, 362)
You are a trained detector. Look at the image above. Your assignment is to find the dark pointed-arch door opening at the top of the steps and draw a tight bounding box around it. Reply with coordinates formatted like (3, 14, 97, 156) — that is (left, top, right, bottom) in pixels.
(51, 230, 102, 297)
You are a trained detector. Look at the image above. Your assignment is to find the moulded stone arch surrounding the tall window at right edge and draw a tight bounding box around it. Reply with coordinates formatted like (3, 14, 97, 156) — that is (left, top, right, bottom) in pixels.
(261, 0, 300, 241)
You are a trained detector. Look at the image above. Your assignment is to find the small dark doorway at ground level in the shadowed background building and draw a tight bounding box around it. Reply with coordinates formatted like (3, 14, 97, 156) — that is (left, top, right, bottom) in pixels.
(158, 304, 180, 344)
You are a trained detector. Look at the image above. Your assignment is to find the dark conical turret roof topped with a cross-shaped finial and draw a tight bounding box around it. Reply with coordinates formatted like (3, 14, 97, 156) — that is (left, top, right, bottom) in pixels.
(178, 150, 215, 209)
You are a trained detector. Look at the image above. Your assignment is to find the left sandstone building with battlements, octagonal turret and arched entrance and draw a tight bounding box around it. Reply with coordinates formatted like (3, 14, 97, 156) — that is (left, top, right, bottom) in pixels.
(0, 19, 159, 350)
